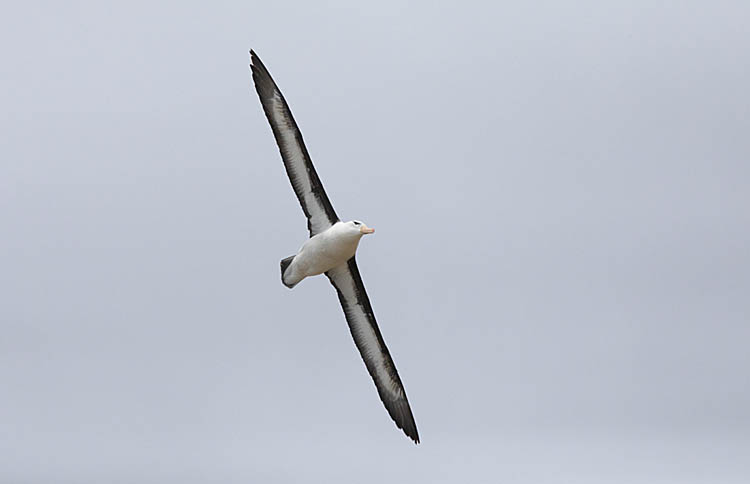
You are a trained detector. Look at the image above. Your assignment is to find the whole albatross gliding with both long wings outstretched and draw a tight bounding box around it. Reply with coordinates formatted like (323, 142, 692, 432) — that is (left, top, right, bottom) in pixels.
(250, 50, 419, 443)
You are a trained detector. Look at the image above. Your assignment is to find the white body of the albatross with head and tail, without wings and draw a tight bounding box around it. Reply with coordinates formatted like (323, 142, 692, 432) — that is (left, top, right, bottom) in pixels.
(282, 221, 373, 287)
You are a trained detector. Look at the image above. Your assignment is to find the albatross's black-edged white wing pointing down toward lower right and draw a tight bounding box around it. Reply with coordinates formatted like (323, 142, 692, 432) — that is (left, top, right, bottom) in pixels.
(326, 257, 419, 443)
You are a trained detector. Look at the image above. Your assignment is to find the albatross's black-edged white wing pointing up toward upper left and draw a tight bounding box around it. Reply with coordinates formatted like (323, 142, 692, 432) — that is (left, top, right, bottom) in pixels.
(250, 50, 339, 236)
